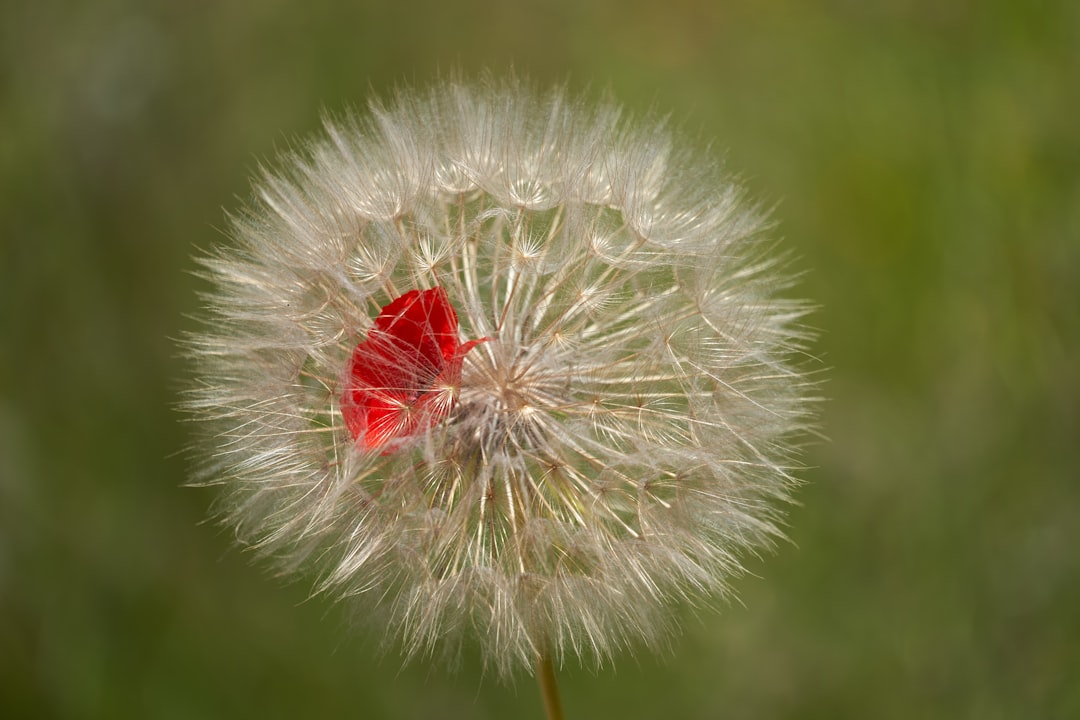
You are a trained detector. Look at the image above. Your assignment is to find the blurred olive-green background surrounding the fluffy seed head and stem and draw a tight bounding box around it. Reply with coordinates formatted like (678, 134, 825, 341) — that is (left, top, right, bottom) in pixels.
(0, 0, 1080, 720)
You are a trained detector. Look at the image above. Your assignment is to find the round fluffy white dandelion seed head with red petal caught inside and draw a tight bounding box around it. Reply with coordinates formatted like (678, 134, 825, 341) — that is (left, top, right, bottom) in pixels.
(187, 80, 809, 708)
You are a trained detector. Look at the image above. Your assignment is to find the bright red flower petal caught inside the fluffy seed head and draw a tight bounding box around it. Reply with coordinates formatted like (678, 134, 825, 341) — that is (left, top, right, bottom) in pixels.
(341, 287, 488, 452)
